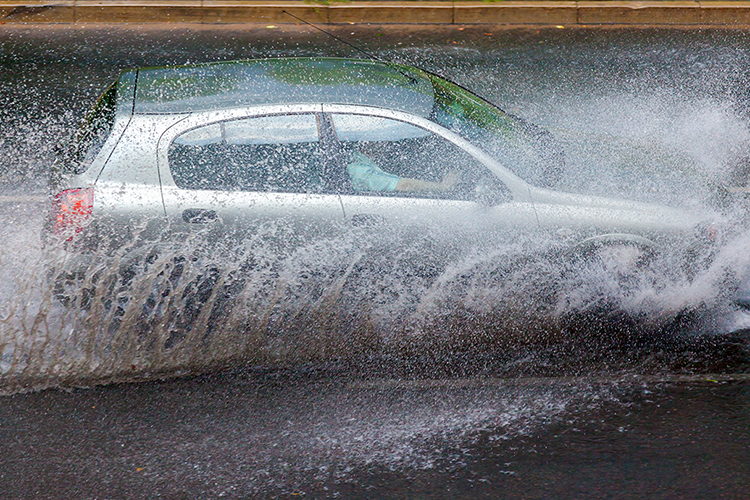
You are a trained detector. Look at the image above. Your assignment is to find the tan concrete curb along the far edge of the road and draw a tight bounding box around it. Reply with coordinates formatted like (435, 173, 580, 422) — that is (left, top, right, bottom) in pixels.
(0, 0, 750, 27)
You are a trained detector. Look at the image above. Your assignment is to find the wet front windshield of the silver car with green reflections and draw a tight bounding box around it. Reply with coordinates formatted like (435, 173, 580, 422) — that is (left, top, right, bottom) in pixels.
(431, 76, 556, 186)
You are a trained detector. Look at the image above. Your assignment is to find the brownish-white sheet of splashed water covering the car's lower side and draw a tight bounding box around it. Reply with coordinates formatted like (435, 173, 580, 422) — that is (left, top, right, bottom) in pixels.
(0, 204, 749, 390)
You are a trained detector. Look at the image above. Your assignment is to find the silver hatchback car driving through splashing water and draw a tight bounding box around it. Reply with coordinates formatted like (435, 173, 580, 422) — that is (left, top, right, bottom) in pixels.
(48, 58, 714, 316)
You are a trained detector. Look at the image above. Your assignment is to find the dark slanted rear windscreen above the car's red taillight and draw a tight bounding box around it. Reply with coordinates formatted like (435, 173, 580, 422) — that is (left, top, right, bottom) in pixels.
(63, 83, 117, 174)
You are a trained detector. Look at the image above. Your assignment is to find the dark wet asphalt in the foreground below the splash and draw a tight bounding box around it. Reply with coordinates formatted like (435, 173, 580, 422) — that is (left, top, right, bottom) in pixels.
(0, 372, 750, 500)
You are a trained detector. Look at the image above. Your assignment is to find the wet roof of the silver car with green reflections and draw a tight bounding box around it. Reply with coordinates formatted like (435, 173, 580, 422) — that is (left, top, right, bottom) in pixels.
(129, 58, 434, 117)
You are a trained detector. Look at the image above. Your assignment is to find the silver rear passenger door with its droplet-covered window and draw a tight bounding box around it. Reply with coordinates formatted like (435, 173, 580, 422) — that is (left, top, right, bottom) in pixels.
(159, 106, 350, 258)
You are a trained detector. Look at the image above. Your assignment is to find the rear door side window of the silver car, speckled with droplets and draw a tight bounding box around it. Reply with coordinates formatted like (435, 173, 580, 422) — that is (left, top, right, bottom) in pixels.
(169, 114, 323, 193)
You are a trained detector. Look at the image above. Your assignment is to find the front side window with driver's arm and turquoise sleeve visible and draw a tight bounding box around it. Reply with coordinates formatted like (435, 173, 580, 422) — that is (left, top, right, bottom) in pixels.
(331, 114, 509, 201)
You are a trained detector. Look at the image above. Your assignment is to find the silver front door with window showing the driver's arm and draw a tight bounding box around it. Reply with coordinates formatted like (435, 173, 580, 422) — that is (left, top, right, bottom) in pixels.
(327, 106, 537, 258)
